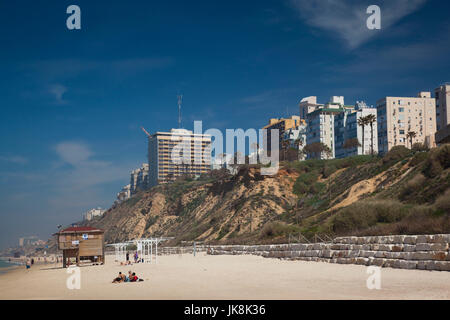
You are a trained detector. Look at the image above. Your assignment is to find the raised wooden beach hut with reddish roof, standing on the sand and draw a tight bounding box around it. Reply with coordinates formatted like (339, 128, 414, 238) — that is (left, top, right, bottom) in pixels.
(55, 227, 105, 268)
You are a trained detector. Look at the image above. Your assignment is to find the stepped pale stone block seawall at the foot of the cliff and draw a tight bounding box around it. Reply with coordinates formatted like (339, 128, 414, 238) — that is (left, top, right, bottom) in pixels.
(208, 234, 450, 271)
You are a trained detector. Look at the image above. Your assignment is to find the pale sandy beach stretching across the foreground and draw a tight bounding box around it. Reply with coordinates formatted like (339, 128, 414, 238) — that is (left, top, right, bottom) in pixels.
(0, 253, 450, 300)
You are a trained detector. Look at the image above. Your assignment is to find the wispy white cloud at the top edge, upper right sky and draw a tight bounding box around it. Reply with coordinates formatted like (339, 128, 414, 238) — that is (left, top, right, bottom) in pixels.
(290, 0, 428, 49)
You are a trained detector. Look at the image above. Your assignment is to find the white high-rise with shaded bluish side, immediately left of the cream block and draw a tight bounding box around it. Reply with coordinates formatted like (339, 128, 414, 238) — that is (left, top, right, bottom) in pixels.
(334, 101, 378, 158)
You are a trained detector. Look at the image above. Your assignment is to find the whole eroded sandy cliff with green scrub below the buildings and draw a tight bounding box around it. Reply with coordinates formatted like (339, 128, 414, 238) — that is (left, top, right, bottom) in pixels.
(89, 146, 450, 244)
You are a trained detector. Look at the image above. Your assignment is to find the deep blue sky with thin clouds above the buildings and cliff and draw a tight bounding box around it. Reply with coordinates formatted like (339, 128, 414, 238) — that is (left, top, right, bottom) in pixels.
(0, 0, 450, 247)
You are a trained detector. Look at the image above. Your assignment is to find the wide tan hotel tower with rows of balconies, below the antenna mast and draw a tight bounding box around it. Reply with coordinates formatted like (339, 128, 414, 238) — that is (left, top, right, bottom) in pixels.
(148, 129, 211, 187)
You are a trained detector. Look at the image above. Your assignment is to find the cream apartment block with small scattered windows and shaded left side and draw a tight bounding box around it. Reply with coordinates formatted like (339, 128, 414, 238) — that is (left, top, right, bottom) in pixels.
(377, 92, 436, 154)
